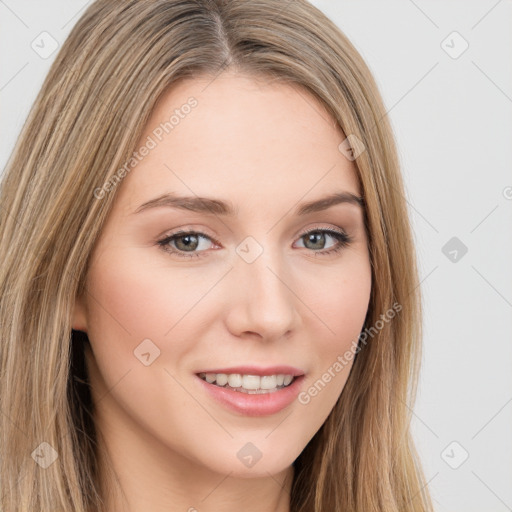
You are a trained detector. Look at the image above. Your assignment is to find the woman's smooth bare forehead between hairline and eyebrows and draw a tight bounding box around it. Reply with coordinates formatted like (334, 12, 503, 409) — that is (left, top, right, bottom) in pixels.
(113, 72, 360, 211)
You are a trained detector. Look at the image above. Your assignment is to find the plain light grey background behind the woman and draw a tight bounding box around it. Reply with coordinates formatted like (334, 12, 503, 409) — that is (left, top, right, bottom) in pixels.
(0, 0, 512, 512)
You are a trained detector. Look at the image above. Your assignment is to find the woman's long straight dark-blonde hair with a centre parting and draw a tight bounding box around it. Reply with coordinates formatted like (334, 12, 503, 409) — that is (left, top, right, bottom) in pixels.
(0, 0, 432, 512)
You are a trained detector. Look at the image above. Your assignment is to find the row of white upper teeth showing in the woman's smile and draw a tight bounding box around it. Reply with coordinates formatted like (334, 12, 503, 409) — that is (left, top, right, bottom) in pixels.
(199, 373, 293, 394)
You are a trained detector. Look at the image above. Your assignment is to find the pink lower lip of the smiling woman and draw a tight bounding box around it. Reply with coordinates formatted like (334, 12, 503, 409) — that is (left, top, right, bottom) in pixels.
(196, 375, 304, 416)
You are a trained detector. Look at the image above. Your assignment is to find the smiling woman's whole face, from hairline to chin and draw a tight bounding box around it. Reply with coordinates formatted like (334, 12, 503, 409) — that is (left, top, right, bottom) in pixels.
(73, 73, 371, 477)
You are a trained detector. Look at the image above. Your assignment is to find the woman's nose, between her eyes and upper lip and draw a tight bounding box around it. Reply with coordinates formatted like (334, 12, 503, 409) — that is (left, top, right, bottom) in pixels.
(226, 242, 301, 341)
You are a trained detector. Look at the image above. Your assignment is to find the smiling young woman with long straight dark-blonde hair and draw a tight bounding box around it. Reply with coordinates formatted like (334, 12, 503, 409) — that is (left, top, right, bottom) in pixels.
(0, 0, 432, 512)
